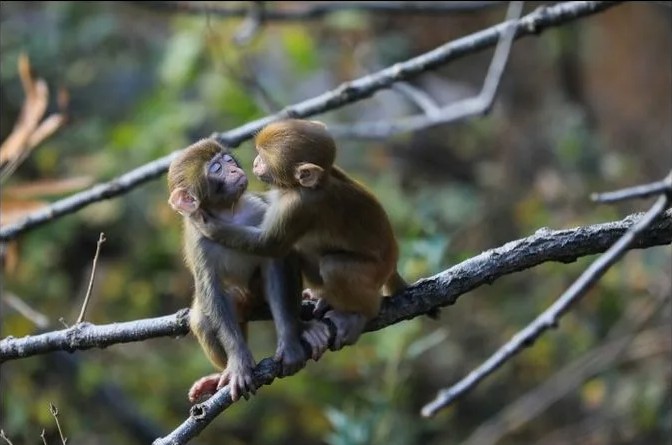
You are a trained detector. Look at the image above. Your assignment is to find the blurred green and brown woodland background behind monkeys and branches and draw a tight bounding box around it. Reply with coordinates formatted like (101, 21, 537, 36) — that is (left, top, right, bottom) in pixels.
(0, 1, 672, 445)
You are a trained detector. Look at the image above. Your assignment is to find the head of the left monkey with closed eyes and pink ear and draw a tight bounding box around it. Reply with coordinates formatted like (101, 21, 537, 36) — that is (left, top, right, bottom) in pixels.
(168, 139, 247, 216)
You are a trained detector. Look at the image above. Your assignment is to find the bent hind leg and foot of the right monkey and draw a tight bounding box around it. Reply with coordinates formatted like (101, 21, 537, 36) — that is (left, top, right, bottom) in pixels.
(314, 255, 384, 350)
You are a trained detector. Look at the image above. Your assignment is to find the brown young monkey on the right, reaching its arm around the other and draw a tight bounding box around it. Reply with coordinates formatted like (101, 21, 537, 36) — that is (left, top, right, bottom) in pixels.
(196, 119, 406, 352)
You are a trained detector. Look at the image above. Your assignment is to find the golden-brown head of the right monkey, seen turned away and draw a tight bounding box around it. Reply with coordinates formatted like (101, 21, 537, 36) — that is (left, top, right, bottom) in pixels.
(252, 119, 336, 188)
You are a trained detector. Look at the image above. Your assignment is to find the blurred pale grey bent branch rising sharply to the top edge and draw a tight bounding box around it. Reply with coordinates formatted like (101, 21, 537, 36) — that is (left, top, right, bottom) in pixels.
(329, 1, 524, 139)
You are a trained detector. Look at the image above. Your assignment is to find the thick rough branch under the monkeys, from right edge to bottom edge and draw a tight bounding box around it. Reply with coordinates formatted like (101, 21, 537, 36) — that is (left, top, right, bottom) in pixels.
(153, 211, 672, 445)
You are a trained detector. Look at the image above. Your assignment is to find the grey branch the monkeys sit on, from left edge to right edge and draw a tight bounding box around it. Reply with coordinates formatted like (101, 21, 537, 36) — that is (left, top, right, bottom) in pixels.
(0, 210, 672, 363)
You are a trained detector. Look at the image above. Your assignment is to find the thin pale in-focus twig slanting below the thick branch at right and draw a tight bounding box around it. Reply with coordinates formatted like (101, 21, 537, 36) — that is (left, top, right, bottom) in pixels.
(422, 191, 668, 417)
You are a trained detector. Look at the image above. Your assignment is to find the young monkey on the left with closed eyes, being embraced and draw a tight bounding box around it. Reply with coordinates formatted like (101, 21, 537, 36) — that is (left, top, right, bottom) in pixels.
(168, 139, 329, 402)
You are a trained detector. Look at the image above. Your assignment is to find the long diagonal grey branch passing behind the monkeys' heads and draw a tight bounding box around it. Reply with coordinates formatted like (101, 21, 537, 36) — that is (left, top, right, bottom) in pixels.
(0, 1, 620, 241)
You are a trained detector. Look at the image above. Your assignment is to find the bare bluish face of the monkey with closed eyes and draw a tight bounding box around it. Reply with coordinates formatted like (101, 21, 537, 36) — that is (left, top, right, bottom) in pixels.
(204, 152, 247, 206)
